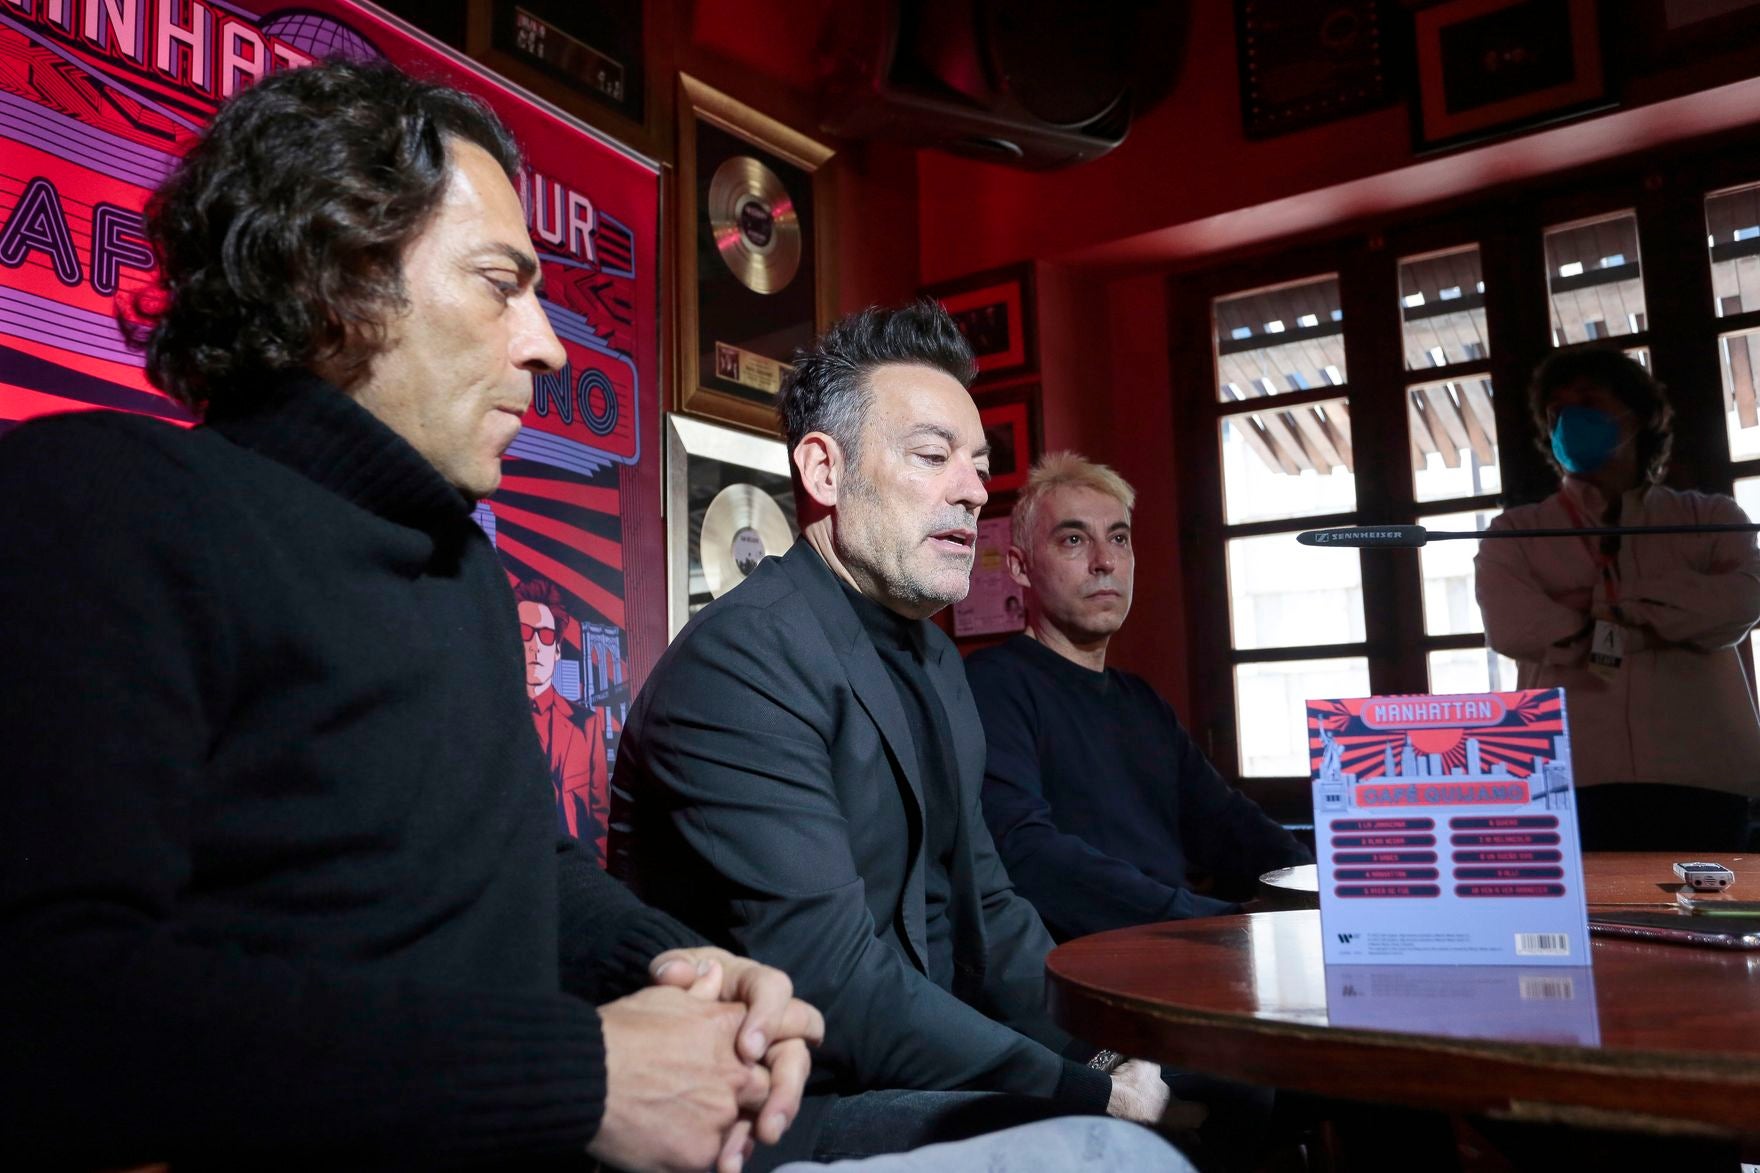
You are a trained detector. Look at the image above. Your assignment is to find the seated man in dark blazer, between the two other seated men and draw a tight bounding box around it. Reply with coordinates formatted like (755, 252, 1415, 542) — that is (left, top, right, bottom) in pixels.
(611, 303, 1167, 1155)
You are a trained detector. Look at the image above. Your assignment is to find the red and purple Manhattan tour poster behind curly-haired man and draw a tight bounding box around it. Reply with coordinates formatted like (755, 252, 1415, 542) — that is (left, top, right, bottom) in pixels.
(0, 0, 665, 859)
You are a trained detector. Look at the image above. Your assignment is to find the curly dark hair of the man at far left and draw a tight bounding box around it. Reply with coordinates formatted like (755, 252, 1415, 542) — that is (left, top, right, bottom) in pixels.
(125, 62, 519, 410)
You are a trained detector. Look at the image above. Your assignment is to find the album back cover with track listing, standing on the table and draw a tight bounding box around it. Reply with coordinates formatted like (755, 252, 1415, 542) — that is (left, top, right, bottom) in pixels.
(1308, 689, 1589, 965)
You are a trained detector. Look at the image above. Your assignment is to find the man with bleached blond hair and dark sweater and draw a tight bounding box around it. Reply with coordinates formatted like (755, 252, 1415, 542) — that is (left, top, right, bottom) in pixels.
(966, 453, 1309, 941)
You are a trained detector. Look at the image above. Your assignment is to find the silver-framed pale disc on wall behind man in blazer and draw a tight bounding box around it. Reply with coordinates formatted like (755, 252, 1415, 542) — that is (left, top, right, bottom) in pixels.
(665, 412, 799, 636)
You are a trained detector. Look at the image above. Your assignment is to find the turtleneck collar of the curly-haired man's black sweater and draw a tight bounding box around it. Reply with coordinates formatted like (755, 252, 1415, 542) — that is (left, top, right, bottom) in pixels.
(206, 372, 472, 534)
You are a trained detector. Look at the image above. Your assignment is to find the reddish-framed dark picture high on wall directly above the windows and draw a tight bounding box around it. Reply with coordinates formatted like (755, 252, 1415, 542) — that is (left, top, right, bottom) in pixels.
(1412, 0, 1614, 151)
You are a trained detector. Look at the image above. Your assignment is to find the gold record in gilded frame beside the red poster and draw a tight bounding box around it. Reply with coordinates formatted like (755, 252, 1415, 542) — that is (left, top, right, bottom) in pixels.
(678, 74, 836, 433)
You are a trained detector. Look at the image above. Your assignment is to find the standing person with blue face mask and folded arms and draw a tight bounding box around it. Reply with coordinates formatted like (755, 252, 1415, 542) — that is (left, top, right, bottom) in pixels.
(1475, 350, 1760, 852)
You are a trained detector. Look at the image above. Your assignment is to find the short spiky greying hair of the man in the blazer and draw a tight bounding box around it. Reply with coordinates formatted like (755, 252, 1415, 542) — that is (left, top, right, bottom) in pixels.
(776, 298, 979, 465)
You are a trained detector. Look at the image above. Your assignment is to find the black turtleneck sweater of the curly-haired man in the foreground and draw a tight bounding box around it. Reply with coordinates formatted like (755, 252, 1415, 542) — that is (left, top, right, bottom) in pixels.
(0, 377, 695, 1168)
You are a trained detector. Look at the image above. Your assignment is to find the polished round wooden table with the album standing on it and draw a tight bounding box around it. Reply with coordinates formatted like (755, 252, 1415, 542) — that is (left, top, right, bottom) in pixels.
(1047, 854, 1760, 1138)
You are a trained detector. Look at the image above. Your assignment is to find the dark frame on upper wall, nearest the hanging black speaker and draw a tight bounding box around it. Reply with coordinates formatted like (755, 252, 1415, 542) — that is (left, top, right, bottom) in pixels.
(1234, 0, 1397, 139)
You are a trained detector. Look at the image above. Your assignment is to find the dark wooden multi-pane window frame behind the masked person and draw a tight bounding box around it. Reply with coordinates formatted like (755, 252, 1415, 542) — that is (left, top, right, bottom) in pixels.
(1167, 143, 1760, 823)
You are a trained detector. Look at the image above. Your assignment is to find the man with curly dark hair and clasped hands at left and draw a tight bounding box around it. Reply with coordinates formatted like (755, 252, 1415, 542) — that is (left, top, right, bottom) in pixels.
(0, 63, 820, 1169)
